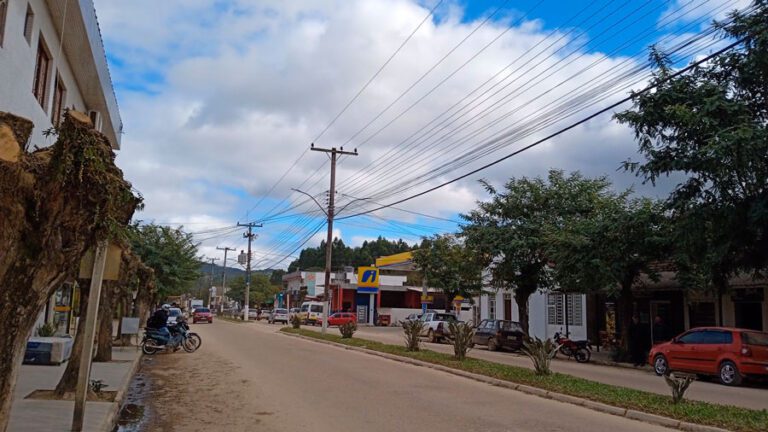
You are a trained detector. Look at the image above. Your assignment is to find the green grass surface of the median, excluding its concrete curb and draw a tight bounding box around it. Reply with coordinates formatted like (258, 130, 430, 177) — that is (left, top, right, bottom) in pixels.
(281, 327, 768, 432)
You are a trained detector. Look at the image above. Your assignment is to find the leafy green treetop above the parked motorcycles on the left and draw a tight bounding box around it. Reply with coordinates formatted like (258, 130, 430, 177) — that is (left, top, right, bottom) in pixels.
(128, 222, 200, 300)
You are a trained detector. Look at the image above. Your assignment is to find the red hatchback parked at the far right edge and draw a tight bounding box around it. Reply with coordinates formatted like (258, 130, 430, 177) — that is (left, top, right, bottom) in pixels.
(648, 327, 768, 386)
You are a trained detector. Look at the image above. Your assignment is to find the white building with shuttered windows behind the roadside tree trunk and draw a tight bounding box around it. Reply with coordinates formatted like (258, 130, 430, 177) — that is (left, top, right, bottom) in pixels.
(475, 288, 587, 340)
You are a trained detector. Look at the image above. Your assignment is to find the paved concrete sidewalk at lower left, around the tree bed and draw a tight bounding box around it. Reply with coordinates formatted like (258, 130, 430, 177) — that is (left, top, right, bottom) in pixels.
(8, 347, 141, 432)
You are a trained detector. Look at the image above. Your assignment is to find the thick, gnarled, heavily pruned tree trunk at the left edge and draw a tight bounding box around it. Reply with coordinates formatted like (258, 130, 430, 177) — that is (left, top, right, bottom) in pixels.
(0, 111, 141, 431)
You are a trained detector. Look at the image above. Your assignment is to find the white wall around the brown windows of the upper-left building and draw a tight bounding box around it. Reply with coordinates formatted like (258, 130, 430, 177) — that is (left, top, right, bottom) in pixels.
(0, 0, 87, 147)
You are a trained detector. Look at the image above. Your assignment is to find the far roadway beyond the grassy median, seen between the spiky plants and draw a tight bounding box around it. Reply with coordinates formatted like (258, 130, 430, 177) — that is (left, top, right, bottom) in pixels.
(304, 326, 768, 409)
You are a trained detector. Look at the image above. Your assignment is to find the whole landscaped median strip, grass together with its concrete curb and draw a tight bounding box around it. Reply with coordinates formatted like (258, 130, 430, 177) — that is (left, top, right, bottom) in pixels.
(281, 327, 768, 432)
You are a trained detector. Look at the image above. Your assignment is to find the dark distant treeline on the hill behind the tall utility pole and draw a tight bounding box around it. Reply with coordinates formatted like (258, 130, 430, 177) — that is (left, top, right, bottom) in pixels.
(288, 237, 416, 270)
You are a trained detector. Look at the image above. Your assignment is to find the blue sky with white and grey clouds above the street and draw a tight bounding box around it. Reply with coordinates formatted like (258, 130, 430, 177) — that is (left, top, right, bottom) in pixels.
(95, 0, 748, 268)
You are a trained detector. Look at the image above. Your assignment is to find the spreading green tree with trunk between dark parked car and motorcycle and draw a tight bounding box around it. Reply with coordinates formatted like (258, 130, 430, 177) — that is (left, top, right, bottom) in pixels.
(461, 170, 610, 333)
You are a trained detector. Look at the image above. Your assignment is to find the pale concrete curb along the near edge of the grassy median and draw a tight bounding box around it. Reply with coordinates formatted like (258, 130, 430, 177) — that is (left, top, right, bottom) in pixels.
(278, 331, 729, 432)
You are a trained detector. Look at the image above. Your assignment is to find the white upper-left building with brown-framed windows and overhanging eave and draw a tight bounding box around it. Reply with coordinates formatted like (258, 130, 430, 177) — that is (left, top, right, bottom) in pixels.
(0, 0, 122, 149)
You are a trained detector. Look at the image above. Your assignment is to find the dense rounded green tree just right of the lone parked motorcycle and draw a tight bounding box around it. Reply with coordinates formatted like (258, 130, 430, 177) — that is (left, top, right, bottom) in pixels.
(547, 197, 671, 349)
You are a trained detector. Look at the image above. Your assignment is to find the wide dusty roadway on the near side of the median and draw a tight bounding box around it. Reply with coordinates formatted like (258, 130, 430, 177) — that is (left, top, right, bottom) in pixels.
(171, 320, 669, 432)
